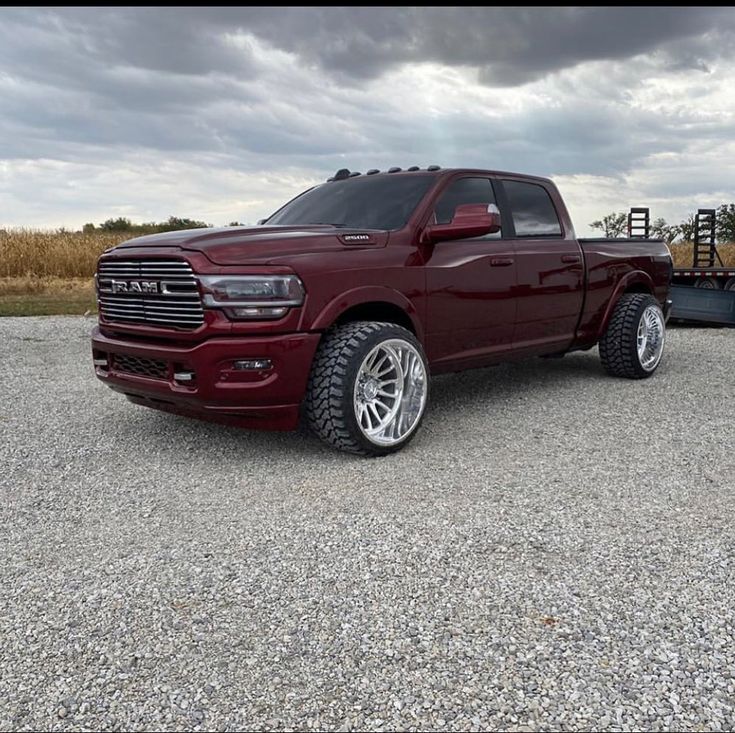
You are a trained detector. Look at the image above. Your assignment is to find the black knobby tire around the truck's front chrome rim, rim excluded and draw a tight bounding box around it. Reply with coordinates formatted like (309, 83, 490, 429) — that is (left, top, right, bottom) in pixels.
(305, 321, 429, 456)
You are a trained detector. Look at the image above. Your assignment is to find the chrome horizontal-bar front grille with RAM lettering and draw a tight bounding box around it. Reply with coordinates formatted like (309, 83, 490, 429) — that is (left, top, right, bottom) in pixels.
(97, 259, 204, 330)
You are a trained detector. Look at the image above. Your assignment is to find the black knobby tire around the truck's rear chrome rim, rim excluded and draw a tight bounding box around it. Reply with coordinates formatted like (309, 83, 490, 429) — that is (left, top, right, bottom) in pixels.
(599, 293, 663, 379)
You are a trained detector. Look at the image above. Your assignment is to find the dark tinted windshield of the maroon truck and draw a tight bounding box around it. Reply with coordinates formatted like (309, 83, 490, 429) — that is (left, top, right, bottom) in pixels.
(265, 173, 435, 229)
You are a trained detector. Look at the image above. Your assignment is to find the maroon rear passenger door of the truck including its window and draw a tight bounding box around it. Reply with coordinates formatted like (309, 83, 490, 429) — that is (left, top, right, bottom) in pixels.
(498, 178, 584, 354)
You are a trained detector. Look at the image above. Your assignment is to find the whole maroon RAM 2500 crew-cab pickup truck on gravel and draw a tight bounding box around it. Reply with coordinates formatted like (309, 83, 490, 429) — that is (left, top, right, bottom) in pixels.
(92, 166, 672, 455)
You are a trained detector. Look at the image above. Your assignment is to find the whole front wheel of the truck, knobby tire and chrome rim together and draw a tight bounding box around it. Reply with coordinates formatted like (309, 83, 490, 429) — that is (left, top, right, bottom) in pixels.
(306, 321, 429, 456)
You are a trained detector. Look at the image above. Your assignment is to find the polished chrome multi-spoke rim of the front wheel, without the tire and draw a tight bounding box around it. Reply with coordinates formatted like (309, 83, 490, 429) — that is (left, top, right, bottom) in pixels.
(353, 339, 428, 446)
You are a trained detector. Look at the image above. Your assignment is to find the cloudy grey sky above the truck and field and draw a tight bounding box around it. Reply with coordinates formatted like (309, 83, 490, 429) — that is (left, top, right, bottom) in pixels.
(0, 7, 735, 233)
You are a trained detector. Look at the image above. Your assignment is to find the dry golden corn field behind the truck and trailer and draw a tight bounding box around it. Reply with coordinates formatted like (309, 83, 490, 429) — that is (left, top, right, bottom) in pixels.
(0, 229, 735, 287)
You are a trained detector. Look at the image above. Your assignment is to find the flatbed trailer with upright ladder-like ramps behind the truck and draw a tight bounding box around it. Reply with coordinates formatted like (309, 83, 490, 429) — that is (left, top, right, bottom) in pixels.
(628, 207, 735, 326)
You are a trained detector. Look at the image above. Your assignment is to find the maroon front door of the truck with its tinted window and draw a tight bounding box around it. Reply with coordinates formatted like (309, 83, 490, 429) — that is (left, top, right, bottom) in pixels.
(426, 176, 516, 371)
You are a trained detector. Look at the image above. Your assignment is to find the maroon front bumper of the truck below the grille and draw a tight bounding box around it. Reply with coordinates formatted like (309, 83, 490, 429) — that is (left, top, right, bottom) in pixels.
(92, 327, 320, 430)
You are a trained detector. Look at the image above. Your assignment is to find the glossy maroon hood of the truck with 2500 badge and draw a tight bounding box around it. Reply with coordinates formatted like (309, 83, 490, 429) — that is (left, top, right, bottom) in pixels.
(115, 224, 388, 265)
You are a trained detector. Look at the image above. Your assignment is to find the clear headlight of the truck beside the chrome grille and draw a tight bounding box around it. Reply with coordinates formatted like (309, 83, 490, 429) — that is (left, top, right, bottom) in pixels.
(199, 275, 304, 319)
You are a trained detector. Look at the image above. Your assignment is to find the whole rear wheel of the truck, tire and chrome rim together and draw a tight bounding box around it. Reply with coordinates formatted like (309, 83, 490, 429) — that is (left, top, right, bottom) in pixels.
(600, 293, 666, 379)
